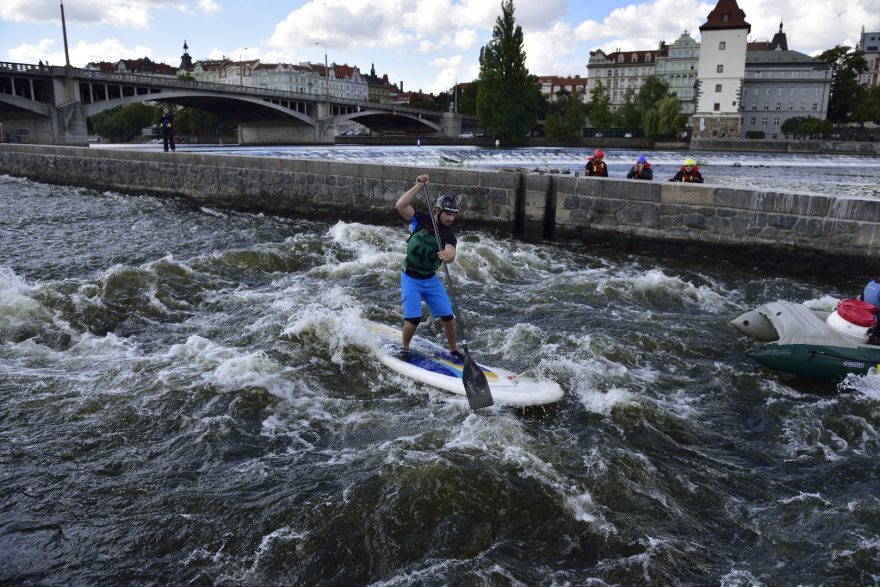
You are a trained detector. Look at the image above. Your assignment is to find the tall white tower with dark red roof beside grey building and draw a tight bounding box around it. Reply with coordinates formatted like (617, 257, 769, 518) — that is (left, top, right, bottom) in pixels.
(693, 0, 752, 139)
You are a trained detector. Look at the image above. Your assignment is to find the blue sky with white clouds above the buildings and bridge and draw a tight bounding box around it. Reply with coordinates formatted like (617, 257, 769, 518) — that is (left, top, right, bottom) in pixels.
(0, 0, 880, 92)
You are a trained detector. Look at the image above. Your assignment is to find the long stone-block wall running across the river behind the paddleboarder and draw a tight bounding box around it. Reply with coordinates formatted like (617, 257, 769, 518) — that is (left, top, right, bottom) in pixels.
(0, 144, 880, 276)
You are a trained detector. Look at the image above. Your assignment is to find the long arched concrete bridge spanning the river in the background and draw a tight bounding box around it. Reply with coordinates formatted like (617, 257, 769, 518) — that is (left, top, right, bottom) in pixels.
(0, 62, 476, 145)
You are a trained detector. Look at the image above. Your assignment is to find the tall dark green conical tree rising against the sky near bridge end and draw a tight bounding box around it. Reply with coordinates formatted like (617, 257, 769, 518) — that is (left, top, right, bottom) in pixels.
(477, 0, 541, 145)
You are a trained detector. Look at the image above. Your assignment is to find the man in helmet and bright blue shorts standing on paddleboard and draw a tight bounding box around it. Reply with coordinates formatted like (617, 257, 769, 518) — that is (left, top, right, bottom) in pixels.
(395, 175, 462, 359)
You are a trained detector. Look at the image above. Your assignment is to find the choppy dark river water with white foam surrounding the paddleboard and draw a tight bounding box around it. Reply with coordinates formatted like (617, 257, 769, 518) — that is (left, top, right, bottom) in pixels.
(0, 147, 880, 587)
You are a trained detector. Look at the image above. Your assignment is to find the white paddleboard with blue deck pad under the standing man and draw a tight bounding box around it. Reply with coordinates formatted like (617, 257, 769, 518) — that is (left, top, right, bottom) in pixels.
(366, 321, 563, 406)
